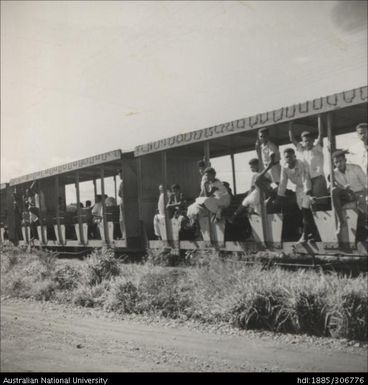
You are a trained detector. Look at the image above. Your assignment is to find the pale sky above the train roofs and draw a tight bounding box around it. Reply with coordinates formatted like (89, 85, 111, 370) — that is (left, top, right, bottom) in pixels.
(1, 1, 367, 201)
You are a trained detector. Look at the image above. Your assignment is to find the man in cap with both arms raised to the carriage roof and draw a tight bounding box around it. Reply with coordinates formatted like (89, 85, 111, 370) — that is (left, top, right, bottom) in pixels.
(289, 123, 328, 197)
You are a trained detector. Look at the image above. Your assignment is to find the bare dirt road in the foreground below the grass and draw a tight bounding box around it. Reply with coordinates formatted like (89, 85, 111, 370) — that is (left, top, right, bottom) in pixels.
(1, 299, 367, 372)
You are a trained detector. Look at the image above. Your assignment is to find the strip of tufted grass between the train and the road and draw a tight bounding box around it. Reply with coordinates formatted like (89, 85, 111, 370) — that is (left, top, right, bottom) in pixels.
(1, 248, 368, 341)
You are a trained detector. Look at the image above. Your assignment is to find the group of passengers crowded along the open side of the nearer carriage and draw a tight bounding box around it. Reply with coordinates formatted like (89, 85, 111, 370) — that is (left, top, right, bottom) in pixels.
(154, 123, 368, 243)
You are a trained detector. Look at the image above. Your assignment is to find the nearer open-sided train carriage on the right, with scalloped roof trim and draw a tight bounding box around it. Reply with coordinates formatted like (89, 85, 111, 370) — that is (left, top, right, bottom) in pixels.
(135, 87, 368, 256)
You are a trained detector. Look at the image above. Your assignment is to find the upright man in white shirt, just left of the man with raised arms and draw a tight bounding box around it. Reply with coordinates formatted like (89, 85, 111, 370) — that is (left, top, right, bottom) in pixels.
(256, 128, 281, 184)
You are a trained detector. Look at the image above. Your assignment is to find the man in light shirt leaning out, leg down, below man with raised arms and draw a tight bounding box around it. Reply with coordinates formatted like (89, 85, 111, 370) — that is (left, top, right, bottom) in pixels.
(278, 148, 318, 243)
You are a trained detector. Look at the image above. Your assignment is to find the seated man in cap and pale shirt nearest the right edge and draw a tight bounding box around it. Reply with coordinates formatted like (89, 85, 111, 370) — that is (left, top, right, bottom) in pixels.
(332, 150, 367, 235)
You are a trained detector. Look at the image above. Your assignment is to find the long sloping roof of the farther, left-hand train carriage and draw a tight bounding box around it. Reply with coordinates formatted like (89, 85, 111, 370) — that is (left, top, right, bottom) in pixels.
(9, 149, 133, 186)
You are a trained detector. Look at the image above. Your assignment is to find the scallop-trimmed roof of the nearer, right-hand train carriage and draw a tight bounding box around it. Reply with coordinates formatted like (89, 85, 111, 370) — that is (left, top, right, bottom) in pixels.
(134, 86, 368, 157)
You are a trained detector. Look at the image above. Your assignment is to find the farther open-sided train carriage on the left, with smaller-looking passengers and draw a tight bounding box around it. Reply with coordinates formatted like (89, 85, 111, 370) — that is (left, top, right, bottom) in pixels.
(10, 150, 142, 250)
